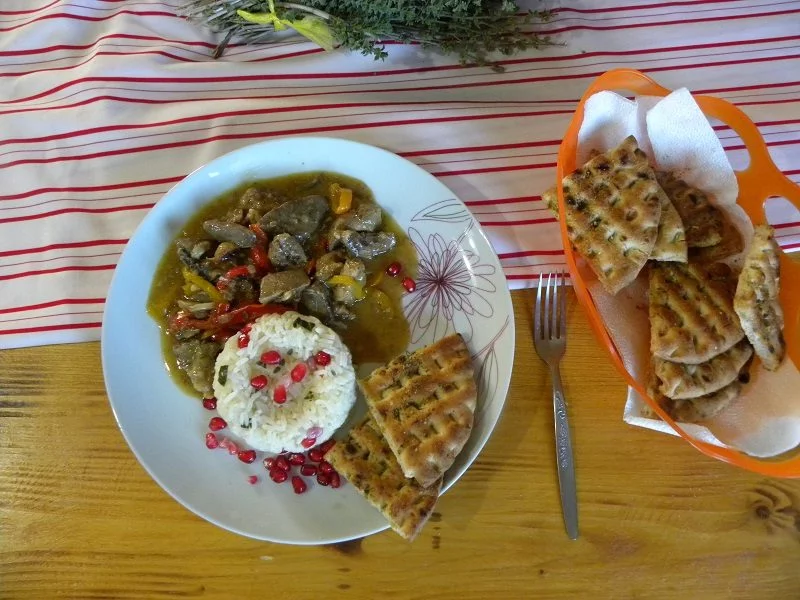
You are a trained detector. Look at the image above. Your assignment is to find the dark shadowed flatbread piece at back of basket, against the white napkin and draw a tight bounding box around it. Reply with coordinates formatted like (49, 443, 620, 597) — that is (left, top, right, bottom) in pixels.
(656, 171, 723, 248)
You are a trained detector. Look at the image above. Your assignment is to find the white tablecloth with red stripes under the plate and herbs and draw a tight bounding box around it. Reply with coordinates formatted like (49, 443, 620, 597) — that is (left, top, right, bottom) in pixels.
(0, 0, 800, 347)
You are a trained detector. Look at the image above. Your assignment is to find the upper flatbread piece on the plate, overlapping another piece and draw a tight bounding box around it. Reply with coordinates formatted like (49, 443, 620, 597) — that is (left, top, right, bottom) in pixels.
(359, 334, 478, 487)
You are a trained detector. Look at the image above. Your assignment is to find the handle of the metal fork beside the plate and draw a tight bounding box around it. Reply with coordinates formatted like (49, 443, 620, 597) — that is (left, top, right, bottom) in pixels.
(550, 364, 578, 540)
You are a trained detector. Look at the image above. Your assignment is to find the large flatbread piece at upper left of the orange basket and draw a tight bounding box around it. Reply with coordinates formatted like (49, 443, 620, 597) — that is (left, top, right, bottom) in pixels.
(563, 136, 664, 294)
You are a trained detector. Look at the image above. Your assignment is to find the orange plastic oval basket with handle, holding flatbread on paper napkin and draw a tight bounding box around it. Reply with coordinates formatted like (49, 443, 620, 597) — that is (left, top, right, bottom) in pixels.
(557, 69, 800, 477)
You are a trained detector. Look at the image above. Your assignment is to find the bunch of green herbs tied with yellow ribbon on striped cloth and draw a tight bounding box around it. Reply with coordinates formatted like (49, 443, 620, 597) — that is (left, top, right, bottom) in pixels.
(181, 0, 550, 64)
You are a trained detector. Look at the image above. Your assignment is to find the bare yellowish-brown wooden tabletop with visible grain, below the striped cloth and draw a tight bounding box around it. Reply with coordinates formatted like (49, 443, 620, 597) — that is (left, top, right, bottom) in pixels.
(0, 291, 800, 600)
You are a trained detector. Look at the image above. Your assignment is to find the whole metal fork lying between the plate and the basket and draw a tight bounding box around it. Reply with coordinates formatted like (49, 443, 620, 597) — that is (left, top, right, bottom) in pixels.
(533, 271, 578, 540)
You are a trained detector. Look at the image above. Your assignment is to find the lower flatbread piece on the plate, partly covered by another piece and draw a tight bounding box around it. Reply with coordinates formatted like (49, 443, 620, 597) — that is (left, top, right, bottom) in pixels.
(325, 415, 442, 540)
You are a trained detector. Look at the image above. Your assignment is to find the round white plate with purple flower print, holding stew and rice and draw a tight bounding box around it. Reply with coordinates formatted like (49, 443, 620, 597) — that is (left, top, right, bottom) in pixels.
(102, 137, 514, 544)
